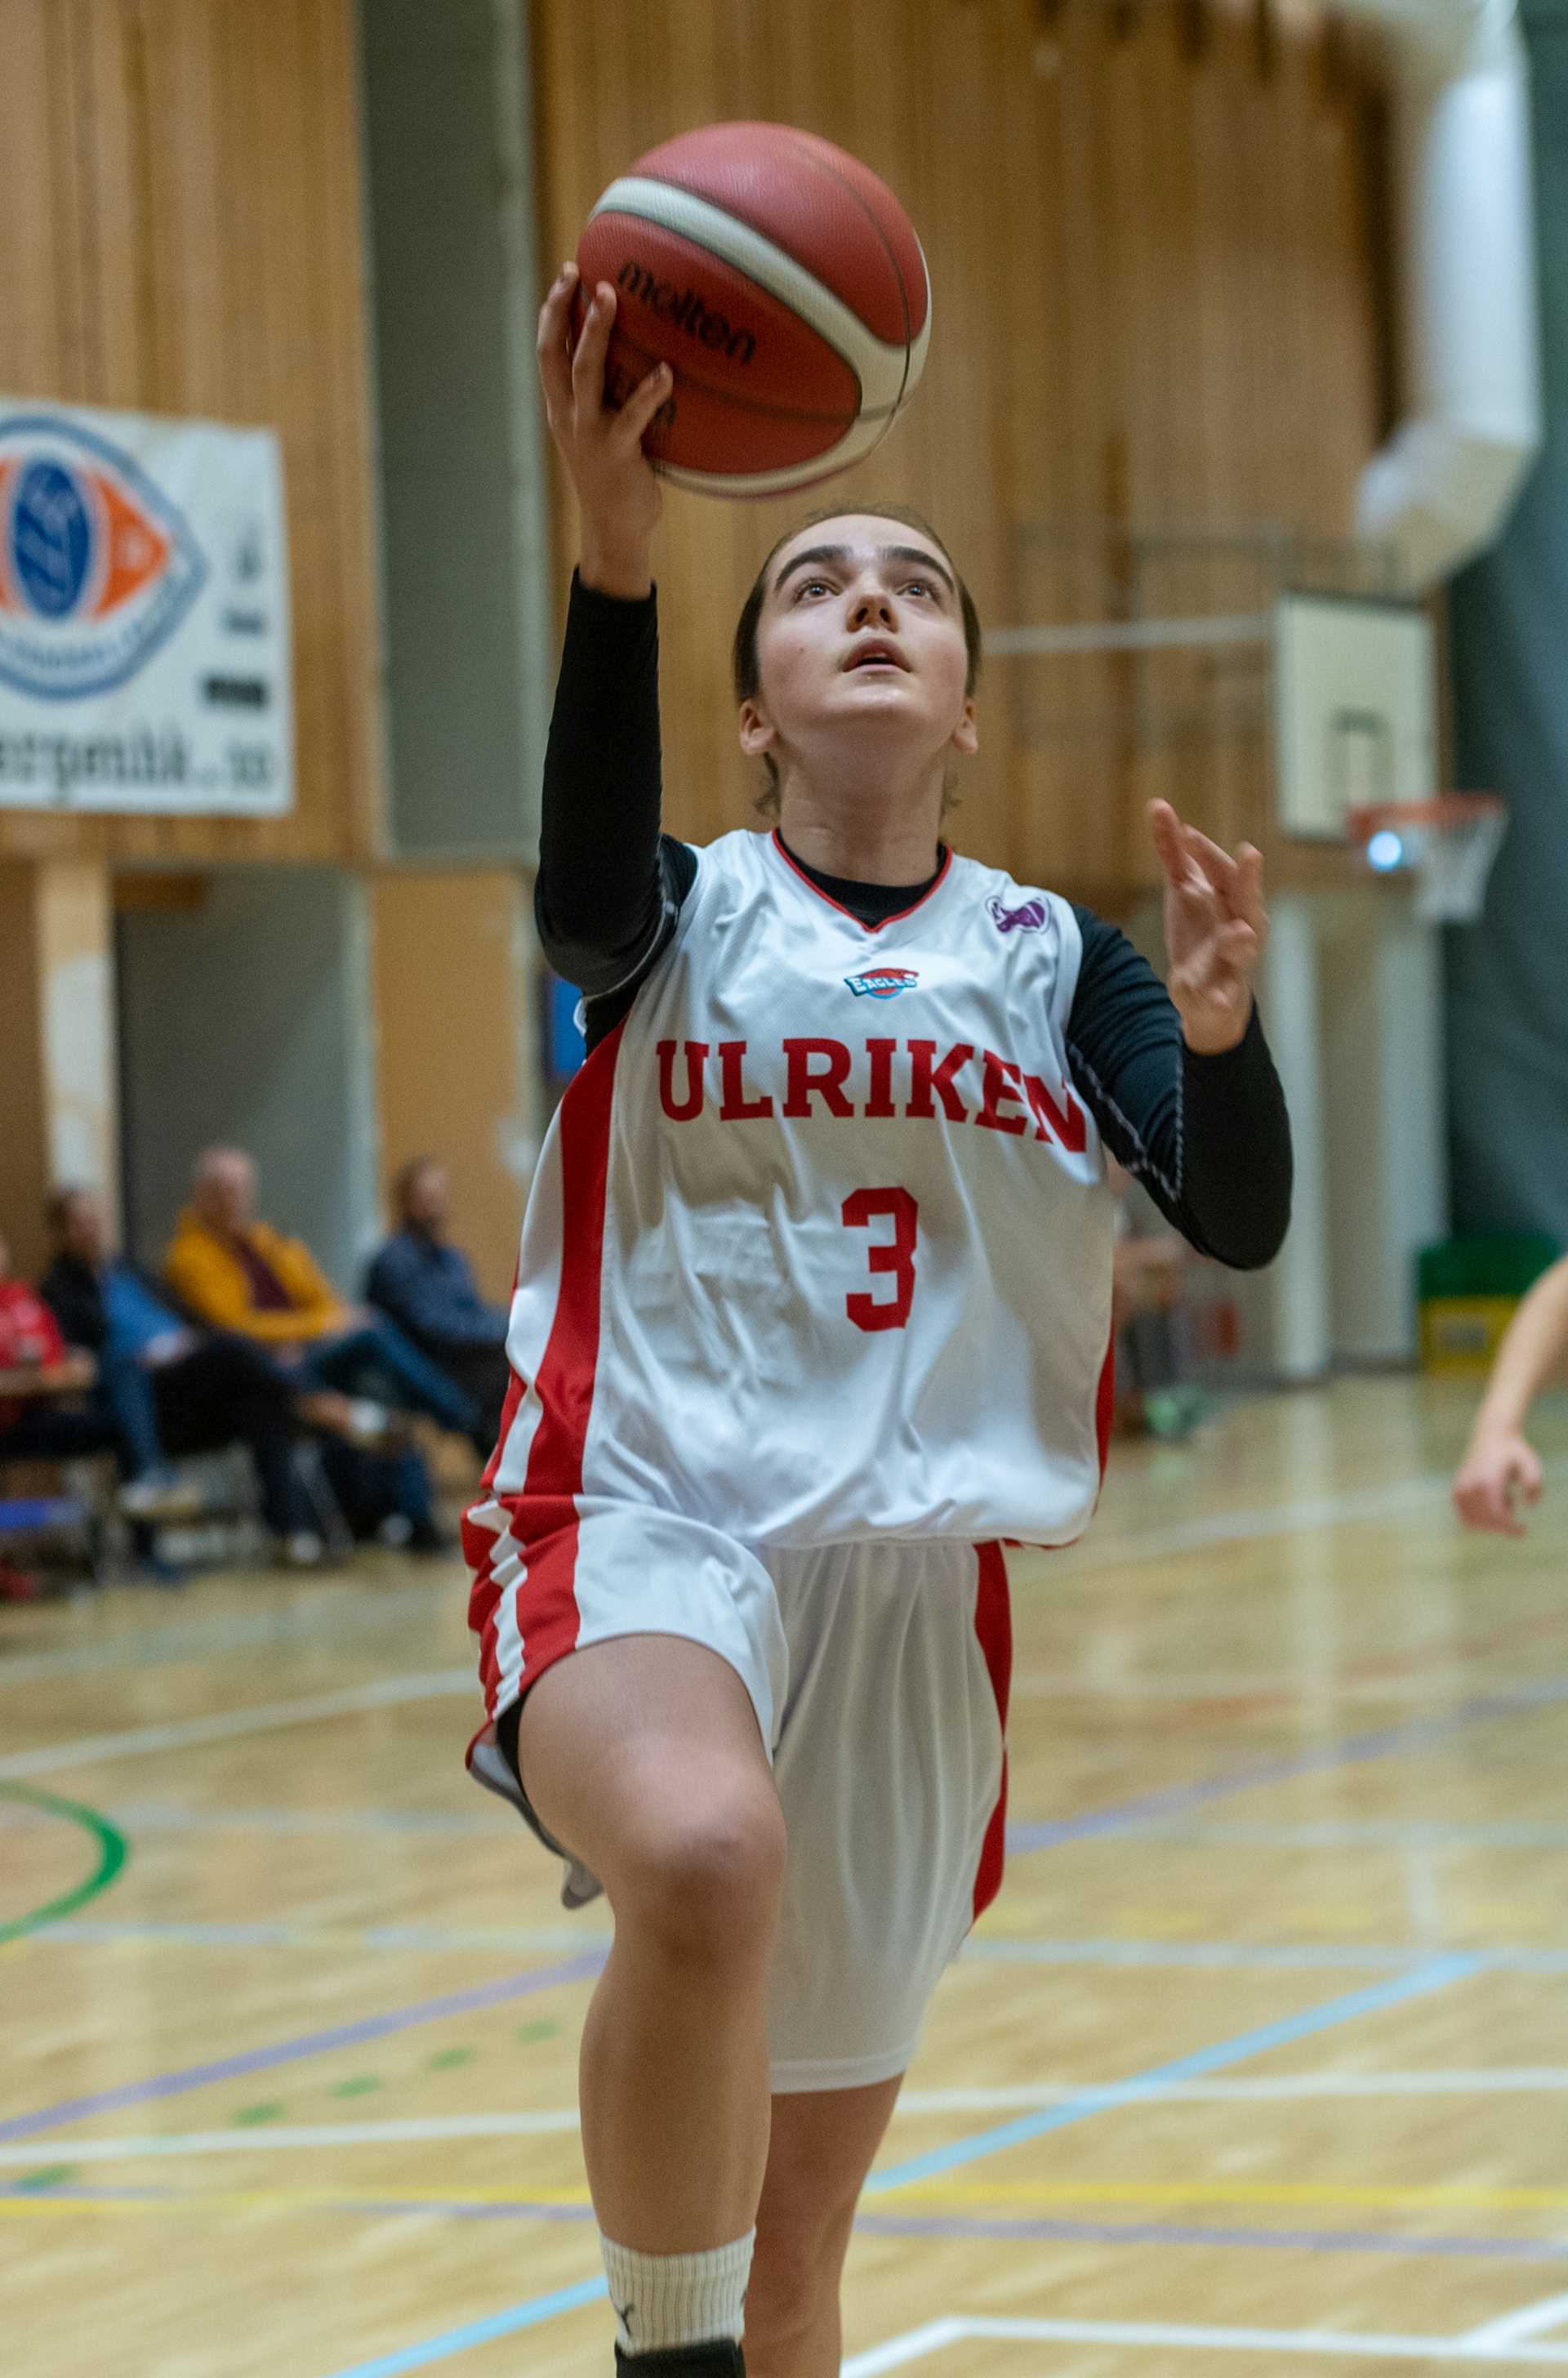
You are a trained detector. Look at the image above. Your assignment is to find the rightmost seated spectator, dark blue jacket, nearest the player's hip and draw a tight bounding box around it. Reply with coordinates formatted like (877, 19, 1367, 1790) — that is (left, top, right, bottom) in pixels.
(366, 1156, 510, 1451)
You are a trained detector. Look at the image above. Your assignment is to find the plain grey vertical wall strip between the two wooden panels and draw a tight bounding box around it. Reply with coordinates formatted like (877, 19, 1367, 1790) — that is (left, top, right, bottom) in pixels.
(359, 0, 551, 859)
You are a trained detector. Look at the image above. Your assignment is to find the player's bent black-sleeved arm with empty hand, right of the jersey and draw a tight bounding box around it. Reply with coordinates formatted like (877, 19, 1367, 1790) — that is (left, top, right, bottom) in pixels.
(1067, 804, 1293, 1272)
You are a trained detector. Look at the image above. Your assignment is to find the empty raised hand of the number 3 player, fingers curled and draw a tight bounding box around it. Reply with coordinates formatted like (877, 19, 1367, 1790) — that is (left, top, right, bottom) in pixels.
(1150, 801, 1268, 1055)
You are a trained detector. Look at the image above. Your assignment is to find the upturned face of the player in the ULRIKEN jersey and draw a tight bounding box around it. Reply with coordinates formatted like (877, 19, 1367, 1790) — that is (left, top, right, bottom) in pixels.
(742, 511, 974, 754)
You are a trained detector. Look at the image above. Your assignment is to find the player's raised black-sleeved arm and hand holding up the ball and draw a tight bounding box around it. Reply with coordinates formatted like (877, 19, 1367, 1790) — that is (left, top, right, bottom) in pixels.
(535, 266, 693, 1039)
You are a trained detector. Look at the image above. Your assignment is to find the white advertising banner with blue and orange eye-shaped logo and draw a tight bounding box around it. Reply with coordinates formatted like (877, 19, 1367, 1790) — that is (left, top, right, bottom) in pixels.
(0, 397, 295, 818)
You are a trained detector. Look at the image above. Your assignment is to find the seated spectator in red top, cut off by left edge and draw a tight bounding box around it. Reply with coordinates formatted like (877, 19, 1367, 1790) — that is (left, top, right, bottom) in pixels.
(0, 1239, 190, 1524)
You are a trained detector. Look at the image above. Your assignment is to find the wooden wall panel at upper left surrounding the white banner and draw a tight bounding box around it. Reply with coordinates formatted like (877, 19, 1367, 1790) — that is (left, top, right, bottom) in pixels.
(0, 0, 380, 863)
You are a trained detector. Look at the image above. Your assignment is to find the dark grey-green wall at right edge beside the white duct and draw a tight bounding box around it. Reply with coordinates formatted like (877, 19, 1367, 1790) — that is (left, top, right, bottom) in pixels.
(1447, 0, 1568, 1246)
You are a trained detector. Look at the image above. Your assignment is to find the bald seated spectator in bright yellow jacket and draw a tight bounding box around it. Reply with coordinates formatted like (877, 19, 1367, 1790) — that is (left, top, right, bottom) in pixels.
(167, 1149, 489, 1553)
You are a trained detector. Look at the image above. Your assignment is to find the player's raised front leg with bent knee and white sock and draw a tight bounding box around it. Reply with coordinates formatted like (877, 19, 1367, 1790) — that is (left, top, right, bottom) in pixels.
(518, 1636, 786, 2368)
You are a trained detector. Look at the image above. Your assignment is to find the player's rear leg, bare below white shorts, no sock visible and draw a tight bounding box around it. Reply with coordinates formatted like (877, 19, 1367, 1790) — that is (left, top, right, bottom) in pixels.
(746, 2073, 902, 2378)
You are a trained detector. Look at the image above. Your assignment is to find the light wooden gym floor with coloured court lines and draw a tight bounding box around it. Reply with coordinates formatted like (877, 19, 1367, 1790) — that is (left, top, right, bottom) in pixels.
(0, 1379, 1568, 2378)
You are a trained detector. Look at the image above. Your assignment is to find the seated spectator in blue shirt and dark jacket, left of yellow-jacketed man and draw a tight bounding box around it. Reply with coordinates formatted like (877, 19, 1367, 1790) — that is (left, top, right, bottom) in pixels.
(40, 1189, 340, 1567)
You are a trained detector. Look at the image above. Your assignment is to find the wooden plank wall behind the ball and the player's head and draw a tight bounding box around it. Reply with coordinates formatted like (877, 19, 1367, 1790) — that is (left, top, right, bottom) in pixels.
(535, 0, 1380, 903)
